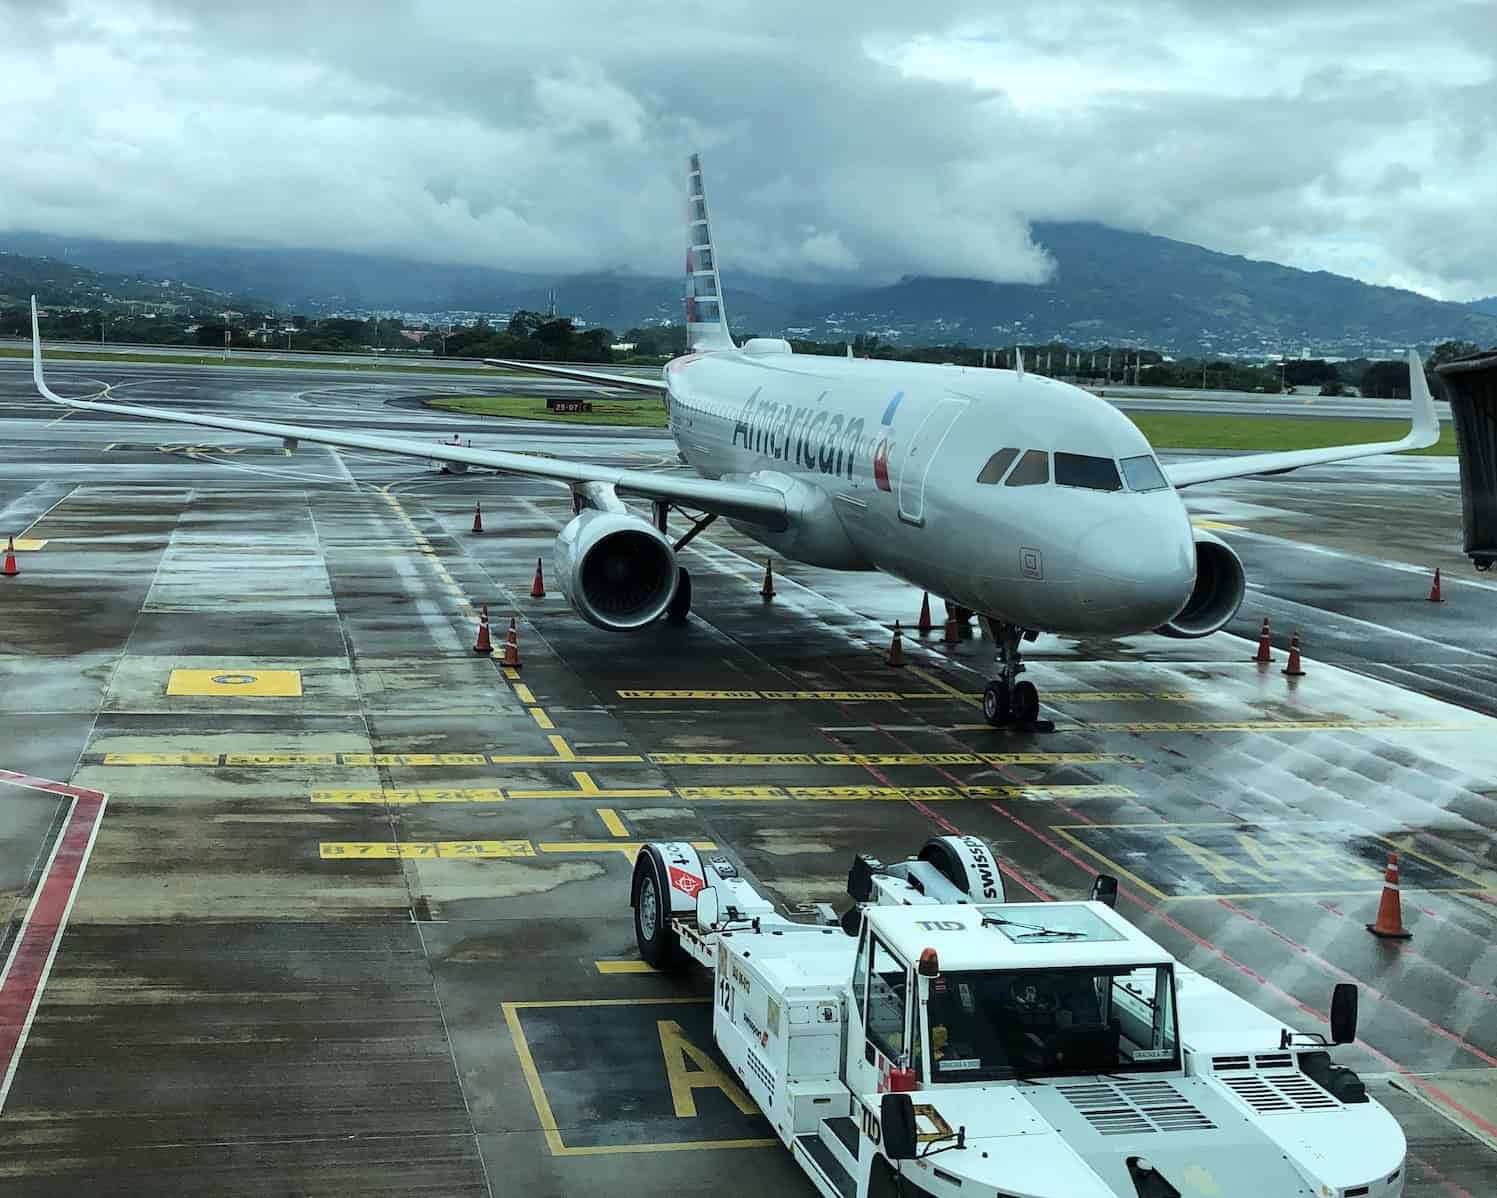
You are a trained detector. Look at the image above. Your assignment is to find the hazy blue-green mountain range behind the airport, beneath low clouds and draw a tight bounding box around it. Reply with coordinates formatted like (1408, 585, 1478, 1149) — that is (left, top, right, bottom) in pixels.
(0, 223, 1497, 356)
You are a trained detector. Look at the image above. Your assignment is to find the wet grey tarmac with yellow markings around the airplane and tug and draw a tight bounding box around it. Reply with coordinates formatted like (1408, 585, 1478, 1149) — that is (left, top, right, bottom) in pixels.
(0, 362, 1497, 1198)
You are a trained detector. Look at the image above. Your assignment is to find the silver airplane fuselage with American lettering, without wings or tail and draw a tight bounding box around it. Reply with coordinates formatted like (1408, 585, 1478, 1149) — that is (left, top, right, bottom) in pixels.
(665, 352, 1196, 635)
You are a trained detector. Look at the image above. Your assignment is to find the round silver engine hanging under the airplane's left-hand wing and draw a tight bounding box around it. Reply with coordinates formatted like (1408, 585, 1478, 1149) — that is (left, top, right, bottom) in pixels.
(552, 509, 678, 632)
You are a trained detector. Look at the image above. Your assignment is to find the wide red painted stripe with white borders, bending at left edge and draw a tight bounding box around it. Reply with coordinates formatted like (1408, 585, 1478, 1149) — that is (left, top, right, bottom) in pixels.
(0, 770, 108, 1110)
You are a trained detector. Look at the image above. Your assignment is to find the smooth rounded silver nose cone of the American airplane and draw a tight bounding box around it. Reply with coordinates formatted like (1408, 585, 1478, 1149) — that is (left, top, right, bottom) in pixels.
(1076, 520, 1196, 632)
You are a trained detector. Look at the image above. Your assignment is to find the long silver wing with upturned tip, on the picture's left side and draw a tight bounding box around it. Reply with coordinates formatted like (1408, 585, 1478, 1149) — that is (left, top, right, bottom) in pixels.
(31, 297, 789, 529)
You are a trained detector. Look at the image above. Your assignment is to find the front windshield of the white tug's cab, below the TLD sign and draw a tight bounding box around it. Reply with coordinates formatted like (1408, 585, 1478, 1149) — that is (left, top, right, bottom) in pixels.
(927, 964, 1180, 1081)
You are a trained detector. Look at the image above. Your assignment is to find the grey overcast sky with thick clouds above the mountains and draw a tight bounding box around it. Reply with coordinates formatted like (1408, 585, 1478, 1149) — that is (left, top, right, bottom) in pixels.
(0, 0, 1497, 300)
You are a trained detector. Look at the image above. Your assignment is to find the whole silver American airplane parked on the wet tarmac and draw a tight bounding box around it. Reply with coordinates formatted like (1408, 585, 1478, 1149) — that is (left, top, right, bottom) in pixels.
(31, 154, 1440, 728)
